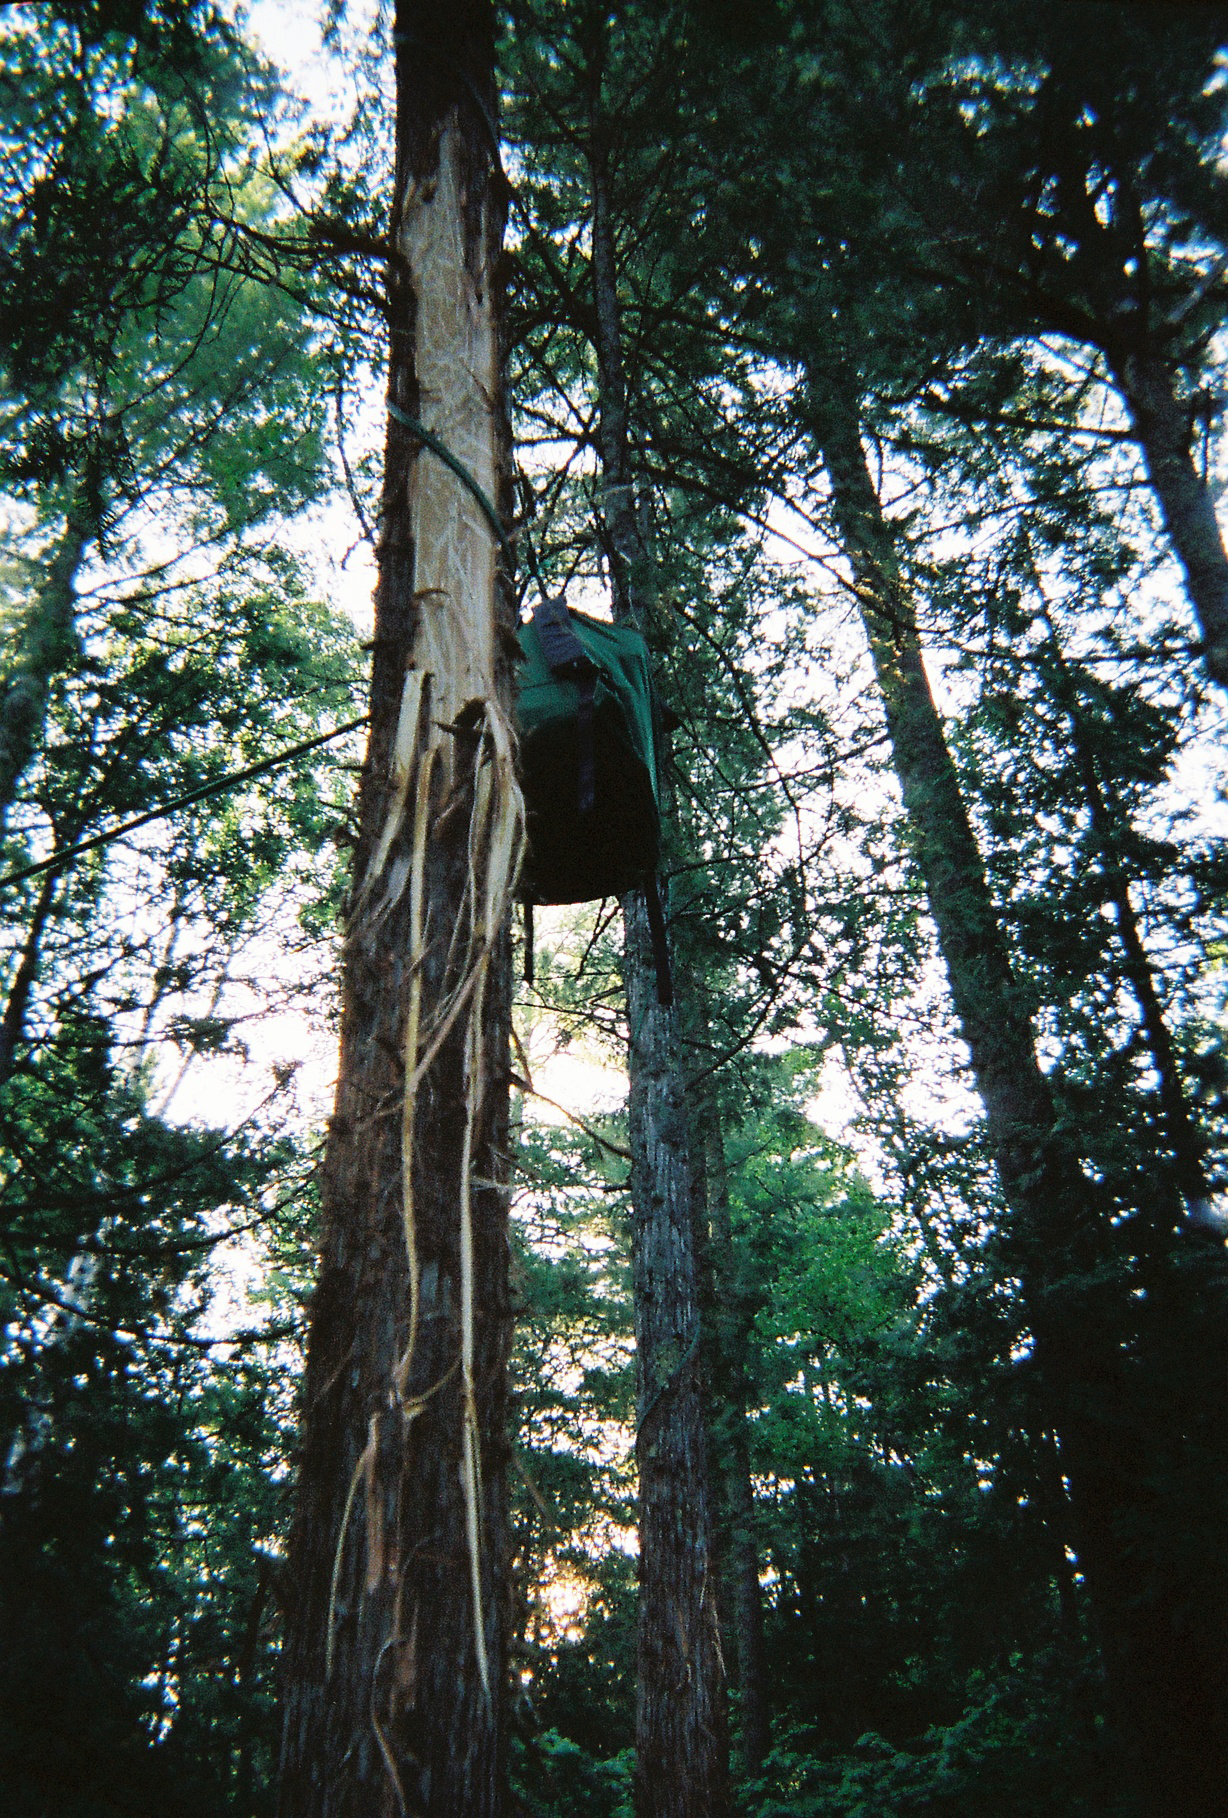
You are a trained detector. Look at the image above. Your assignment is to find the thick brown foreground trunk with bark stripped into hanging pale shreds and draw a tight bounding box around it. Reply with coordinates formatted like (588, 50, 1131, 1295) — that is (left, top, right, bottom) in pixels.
(278, 0, 522, 1818)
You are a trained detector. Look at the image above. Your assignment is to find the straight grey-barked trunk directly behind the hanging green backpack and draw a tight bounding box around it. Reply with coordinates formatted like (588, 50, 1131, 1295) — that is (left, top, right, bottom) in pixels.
(591, 122, 730, 1818)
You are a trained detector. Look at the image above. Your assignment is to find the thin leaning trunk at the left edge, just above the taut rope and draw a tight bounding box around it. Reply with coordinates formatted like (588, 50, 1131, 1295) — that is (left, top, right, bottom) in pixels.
(0, 498, 98, 838)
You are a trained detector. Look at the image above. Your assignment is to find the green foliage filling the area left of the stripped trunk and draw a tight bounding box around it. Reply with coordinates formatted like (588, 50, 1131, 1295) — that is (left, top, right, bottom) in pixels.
(0, 7, 365, 1818)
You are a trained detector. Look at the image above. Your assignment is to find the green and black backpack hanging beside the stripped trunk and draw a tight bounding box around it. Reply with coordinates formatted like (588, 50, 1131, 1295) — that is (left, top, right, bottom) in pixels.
(517, 598, 671, 1004)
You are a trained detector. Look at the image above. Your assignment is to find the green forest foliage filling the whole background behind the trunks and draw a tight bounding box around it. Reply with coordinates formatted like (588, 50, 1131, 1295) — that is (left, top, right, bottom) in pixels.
(0, 0, 1228, 1818)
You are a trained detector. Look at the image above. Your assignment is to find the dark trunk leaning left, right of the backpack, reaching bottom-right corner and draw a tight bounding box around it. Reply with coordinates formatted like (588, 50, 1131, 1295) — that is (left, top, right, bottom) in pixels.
(815, 371, 1228, 1818)
